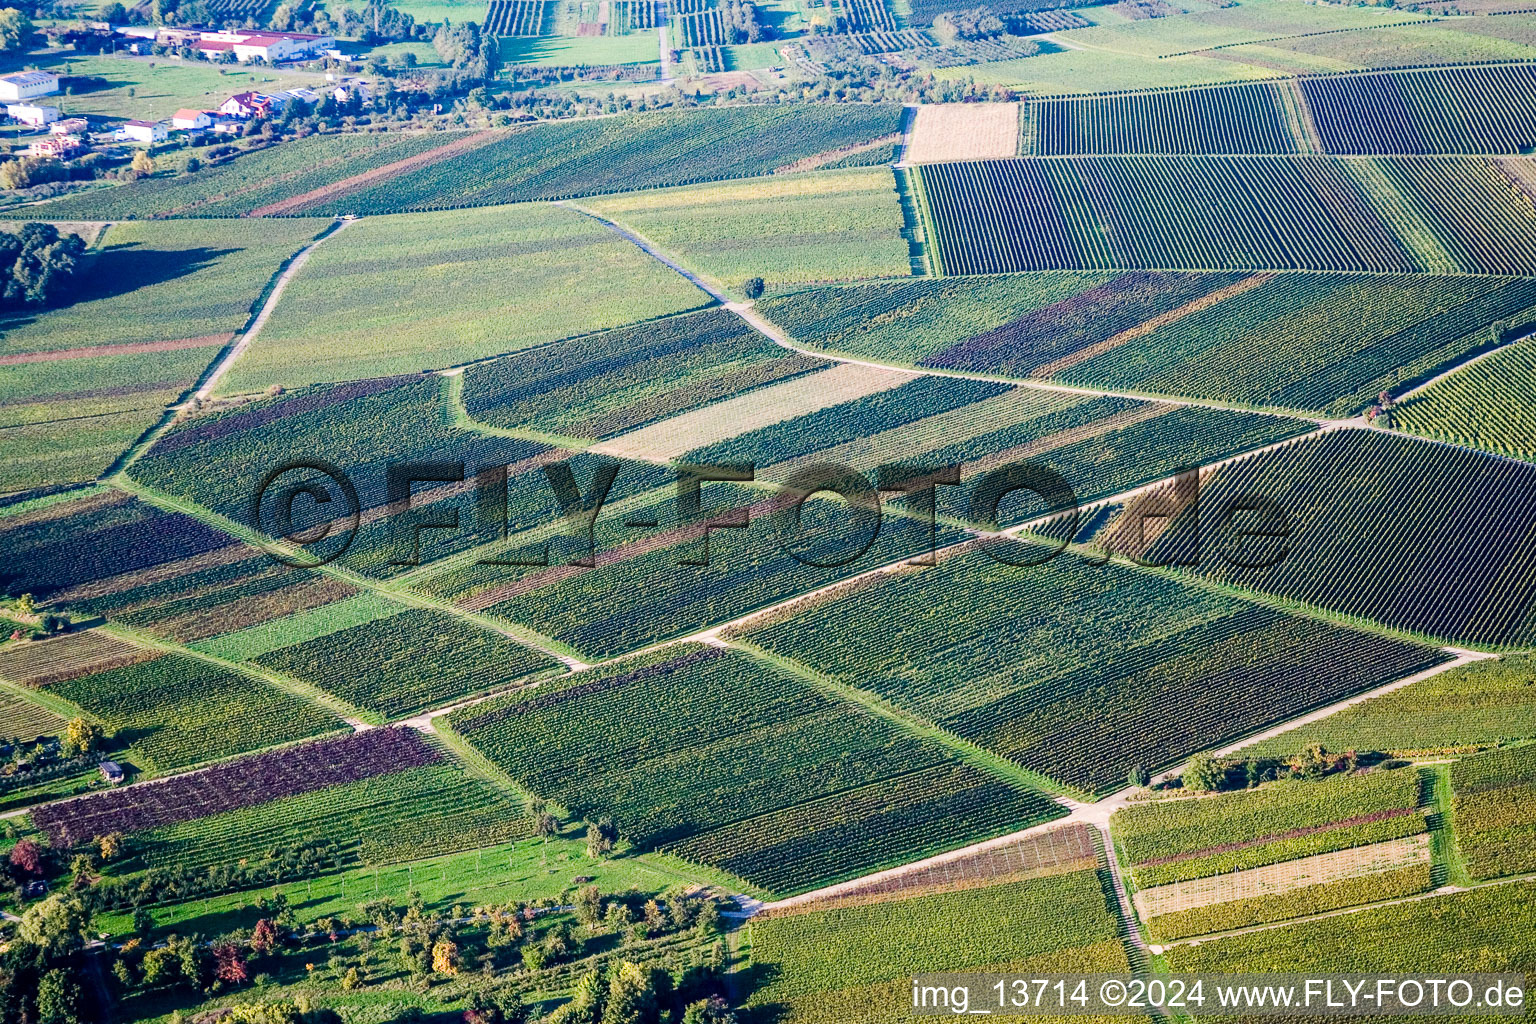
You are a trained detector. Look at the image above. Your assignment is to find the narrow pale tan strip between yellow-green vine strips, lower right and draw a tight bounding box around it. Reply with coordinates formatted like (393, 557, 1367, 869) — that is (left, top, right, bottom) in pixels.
(1135, 834, 1430, 920)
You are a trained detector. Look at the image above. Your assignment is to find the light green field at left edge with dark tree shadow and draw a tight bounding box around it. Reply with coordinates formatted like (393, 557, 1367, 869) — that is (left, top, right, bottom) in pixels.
(0, 221, 324, 493)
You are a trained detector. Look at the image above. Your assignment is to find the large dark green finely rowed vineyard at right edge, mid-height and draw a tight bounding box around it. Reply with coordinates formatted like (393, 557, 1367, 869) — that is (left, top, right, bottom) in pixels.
(1127, 430, 1536, 646)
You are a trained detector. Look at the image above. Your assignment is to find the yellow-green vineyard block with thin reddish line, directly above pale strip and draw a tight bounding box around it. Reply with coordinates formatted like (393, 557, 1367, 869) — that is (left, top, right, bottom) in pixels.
(1114, 769, 1427, 887)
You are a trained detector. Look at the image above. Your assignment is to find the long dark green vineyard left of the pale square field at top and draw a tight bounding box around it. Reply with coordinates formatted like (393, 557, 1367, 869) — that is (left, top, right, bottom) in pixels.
(293, 104, 902, 213)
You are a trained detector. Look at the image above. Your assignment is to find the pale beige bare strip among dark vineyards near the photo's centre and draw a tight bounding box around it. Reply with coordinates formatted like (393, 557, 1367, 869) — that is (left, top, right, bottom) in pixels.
(591, 362, 912, 461)
